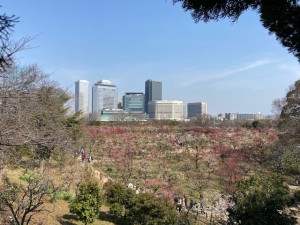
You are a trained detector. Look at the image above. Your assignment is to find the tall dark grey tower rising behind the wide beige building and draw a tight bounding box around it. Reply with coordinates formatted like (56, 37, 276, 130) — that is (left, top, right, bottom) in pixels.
(145, 80, 162, 113)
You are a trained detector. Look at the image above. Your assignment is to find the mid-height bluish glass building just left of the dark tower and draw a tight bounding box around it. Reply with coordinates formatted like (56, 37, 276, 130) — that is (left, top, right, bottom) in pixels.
(123, 92, 145, 113)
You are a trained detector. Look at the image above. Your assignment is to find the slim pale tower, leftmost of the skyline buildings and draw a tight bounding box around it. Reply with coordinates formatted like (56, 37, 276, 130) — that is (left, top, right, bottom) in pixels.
(75, 80, 90, 114)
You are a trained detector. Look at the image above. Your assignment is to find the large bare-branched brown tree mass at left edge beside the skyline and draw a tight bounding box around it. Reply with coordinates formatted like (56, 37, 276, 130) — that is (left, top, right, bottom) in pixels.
(0, 65, 80, 165)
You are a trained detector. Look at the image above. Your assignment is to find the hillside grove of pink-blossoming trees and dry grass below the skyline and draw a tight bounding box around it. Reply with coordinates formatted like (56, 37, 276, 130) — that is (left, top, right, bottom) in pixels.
(0, 124, 300, 225)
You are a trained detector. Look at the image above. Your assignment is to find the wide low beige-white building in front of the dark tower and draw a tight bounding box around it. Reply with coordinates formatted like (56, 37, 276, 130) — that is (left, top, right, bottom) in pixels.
(148, 100, 184, 120)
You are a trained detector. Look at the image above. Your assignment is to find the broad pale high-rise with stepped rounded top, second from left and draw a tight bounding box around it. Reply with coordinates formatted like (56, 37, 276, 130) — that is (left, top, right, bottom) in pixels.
(92, 80, 118, 115)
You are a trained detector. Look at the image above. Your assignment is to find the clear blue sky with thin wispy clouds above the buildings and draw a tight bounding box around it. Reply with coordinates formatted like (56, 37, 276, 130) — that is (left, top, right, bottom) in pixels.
(0, 0, 300, 115)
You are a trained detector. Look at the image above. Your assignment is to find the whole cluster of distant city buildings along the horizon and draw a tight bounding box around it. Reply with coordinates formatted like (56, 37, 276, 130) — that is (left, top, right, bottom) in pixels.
(75, 79, 265, 121)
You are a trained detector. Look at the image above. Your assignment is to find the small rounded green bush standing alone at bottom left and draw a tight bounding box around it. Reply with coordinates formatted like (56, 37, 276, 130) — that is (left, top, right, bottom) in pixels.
(70, 182, 102, 225)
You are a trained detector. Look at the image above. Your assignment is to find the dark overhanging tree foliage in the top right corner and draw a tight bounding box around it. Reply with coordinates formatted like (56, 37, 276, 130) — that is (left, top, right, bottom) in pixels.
(173, 0, 300, 61)
